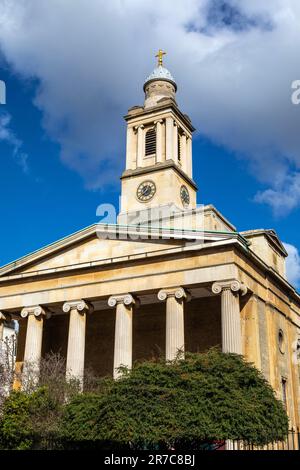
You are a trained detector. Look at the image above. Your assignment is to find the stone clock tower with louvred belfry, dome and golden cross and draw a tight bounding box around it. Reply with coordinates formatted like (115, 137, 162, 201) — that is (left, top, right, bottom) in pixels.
(119, 50, 197, 223)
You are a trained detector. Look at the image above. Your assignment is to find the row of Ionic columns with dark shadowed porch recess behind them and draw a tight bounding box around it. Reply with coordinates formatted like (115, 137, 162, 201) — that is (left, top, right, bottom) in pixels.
(1, 264, 246, 382)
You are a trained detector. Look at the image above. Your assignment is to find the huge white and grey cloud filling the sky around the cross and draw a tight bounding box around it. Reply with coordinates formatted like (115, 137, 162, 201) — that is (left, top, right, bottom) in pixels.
(0, 0, 300, 202)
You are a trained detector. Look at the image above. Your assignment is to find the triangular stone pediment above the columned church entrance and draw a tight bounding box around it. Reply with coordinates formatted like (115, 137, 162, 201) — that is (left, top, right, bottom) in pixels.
(0, 224, 243, 277)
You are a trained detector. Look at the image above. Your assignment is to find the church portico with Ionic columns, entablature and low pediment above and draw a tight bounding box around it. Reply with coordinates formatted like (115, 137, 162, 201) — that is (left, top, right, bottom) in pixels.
(1, 217, 252, 381)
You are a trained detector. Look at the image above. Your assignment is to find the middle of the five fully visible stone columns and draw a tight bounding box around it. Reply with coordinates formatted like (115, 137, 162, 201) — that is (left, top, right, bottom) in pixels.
(108, 294, 136, 379)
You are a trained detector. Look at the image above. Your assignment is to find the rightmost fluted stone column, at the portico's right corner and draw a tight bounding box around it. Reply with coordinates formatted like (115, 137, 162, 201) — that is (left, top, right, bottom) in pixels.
(212, 280, 247, 354)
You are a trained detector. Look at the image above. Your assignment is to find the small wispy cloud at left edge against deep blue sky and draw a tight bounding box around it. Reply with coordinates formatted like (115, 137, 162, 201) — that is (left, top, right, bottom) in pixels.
(0, 112, 29, 173)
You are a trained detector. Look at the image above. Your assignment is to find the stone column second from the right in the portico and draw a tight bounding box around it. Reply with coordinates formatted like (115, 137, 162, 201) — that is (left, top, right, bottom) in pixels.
(158, 287, 189, 361)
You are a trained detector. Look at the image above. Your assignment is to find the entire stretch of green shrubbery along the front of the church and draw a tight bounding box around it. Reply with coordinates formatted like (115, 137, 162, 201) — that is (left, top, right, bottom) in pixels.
(0, 349, 288, 451)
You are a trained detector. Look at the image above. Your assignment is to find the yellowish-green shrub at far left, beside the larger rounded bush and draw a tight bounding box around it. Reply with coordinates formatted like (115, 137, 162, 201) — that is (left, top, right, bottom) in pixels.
(0, 353, 79, 449)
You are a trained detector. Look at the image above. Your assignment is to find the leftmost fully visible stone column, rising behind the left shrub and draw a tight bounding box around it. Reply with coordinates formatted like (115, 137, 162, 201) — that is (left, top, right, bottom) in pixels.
(21, 305, 50, 381)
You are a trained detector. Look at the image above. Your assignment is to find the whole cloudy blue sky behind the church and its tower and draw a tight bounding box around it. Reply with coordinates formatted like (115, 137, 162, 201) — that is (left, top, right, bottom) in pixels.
(0, 0, 300, 288)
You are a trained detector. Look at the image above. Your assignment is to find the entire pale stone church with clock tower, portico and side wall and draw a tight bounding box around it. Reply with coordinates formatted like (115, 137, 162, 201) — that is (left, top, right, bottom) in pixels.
(0, 54, 300, 430)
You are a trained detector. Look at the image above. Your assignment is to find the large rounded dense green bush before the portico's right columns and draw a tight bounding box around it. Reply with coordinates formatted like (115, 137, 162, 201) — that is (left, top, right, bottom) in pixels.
(62, 350, 288, 450)
